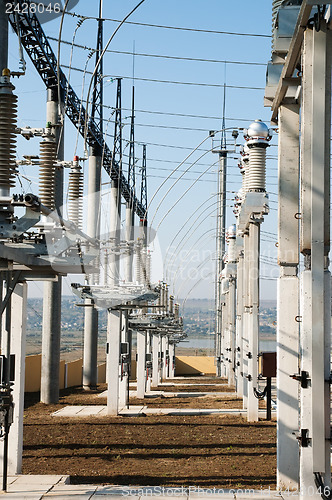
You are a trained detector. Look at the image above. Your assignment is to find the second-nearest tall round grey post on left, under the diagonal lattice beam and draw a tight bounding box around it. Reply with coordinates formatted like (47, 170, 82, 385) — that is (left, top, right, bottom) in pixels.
(83, 148, 101, 390)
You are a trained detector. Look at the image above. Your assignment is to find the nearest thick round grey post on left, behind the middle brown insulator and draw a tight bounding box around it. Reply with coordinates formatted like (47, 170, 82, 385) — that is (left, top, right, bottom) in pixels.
(40, 88, 64, 404)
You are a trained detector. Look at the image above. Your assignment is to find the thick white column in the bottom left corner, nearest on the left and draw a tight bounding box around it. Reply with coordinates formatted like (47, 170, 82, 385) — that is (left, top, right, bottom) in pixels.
(0, 283, 27, 475)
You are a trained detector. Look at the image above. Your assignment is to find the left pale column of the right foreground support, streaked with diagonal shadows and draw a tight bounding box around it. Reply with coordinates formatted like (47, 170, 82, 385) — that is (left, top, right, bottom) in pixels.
(277, 105, 300, 490)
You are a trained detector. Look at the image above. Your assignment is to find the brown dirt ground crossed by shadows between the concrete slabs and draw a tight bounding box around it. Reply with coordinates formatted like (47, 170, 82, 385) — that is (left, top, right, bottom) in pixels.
(23, 377, 276, 488)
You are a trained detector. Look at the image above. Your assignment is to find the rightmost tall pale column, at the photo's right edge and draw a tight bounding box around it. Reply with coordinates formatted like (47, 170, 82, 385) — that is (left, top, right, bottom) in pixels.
(300, 24, 332, 499)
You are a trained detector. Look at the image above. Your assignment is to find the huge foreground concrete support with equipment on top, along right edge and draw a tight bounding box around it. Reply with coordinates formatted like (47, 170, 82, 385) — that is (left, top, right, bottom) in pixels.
(265, 0, 332, 499)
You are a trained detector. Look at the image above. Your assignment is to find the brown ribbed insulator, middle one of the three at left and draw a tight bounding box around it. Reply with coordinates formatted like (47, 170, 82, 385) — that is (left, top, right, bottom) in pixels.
(39, 139, 57, 210)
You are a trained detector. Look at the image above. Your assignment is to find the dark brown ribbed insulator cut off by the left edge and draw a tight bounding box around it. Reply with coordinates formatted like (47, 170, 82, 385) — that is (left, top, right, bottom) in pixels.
(0, 70, 17, 192)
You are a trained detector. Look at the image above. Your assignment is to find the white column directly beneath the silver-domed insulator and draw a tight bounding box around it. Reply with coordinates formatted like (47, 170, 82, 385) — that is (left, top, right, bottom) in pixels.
(248, 222, 260, 422)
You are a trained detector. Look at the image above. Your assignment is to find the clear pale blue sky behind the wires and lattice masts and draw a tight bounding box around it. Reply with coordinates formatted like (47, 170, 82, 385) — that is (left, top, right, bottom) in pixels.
(9, 0, 278, 299)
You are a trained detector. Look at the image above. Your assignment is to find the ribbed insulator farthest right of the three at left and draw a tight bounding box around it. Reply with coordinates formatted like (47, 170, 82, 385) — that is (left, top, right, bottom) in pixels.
(68, 159, 83, 229)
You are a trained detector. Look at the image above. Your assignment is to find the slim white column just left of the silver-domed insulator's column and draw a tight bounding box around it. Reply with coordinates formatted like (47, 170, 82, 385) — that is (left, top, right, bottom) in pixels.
(235, 252, 244, 398)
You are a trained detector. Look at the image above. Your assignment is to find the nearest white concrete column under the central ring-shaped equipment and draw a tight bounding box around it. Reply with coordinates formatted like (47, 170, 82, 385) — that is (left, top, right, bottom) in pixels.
(106, 310, 122, 415)
